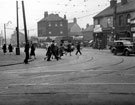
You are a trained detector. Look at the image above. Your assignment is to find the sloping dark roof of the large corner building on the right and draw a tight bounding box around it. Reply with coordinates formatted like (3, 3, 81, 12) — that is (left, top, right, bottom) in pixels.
(94, 0, 135, 18)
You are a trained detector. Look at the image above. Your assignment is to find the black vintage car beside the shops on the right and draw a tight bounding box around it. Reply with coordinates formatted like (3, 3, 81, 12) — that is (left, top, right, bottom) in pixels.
(111, 40, 135, 56)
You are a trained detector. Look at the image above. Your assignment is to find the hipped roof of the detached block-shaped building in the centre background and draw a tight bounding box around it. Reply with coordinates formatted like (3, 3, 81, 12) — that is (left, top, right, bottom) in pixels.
(40, 14, 63, 21)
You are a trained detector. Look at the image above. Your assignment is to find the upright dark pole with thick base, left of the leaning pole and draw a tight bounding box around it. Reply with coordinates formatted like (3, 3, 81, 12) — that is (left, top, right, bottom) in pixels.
(16, 1, 20, 55)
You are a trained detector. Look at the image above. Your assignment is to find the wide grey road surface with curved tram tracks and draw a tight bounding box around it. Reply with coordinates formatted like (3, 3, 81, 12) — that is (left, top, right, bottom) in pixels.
(0, 48, 135, 105)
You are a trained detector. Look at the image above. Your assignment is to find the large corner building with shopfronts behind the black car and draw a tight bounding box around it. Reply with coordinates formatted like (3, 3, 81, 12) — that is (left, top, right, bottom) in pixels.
(93, 0, 135, 48)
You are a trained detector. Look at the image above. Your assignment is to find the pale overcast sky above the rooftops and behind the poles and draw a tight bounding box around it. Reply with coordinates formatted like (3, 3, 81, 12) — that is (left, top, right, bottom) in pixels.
(0, 0, 110, 38)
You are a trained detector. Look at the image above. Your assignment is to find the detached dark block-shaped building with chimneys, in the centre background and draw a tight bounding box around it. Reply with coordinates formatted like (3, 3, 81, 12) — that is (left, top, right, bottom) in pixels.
(37, 12, 68, 38)
